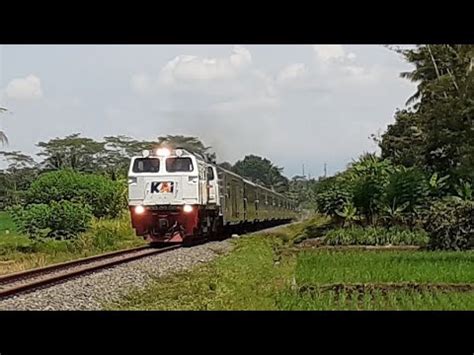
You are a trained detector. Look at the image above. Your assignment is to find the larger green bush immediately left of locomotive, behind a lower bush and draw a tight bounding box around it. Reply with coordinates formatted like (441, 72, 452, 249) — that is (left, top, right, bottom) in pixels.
(26, 170, 126, 218)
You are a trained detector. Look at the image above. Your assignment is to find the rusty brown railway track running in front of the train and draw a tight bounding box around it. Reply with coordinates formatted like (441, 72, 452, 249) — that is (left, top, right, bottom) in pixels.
(0, 244, 182, 299)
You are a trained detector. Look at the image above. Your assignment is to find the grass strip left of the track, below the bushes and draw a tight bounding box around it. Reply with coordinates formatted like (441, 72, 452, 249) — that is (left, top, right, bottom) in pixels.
(0, 212, 145, 275)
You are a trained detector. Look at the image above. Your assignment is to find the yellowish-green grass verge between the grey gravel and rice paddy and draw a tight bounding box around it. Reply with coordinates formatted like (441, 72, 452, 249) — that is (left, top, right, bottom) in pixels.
(104, 236, 293, 310)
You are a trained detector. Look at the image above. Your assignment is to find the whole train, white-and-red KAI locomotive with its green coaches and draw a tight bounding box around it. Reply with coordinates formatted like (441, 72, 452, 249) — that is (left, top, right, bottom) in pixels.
(128, 147, 298, 244)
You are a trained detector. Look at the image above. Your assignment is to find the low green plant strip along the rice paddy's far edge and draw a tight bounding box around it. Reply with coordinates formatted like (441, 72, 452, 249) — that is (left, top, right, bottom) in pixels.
(324, 227, 428, 246)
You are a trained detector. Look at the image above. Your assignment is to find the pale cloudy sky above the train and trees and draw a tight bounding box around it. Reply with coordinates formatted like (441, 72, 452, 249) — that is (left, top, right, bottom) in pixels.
(0, 45, 416, 177)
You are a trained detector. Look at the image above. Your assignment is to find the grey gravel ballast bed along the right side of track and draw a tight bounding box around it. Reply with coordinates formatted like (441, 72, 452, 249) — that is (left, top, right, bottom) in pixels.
(0, 240, 232, 310)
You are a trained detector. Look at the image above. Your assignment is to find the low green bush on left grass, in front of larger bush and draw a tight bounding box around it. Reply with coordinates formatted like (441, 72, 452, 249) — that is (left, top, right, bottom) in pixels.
(11, 201, 92, 239)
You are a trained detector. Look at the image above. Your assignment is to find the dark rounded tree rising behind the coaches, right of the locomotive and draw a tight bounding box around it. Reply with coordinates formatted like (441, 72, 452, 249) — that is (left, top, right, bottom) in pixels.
(232, 155, 289, 193)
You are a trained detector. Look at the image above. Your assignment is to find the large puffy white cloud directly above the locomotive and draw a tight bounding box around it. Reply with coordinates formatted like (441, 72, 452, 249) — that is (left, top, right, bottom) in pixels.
(160, 46, 252, 84)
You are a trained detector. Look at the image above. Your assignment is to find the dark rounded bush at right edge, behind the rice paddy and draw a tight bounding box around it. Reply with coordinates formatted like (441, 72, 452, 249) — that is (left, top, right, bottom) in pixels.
(425, 197, 474, 250)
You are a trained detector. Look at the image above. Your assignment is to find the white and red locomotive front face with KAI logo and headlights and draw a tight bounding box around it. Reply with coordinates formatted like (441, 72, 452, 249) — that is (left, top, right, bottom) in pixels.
(128, 148, 200, 242)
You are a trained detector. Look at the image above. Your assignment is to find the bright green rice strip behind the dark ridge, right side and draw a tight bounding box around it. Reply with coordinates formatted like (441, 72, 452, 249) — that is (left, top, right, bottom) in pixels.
(295, 250, 474, 284)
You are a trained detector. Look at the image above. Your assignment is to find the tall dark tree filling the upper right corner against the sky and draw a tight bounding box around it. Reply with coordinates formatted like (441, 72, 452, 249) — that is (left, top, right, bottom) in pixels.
(380, 45, 474, 186)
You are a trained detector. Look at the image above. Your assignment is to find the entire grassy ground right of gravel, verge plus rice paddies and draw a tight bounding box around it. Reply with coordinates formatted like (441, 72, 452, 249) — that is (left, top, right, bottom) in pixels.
(104, 220, 474, 310)
